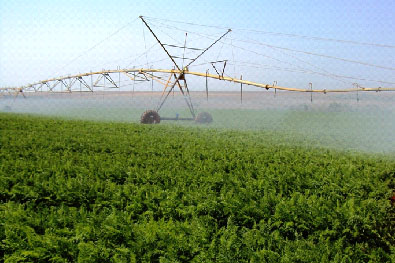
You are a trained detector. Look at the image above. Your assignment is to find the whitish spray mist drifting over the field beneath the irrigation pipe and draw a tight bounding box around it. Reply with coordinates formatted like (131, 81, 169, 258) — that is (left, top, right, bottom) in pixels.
(0, 91, 395, 154)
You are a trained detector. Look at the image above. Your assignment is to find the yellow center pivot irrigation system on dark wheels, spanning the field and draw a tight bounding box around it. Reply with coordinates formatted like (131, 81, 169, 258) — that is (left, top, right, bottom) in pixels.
(0, 16, 395, 124)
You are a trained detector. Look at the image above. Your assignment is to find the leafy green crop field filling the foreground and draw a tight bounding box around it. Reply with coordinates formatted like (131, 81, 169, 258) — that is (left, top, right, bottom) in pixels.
(0, 112, 395, 262)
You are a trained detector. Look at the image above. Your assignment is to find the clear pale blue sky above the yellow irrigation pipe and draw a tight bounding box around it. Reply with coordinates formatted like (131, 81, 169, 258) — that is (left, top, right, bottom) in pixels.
(0, 0, 395, 88)
